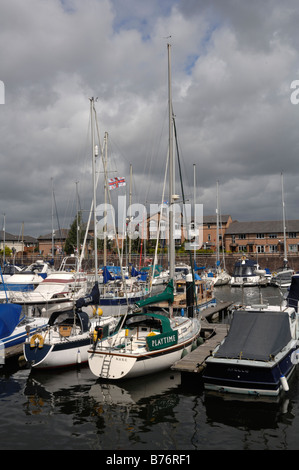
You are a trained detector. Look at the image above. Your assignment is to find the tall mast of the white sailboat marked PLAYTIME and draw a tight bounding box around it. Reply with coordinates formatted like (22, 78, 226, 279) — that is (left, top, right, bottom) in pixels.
(167, 44, 175, 279)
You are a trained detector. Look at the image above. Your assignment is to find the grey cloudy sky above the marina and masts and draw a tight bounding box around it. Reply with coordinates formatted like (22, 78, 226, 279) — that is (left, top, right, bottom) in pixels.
(0, 0, 299, 236)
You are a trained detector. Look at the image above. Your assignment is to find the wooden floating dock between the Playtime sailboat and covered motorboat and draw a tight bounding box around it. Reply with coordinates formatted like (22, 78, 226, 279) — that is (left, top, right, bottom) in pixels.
(171, 302, 231, 375)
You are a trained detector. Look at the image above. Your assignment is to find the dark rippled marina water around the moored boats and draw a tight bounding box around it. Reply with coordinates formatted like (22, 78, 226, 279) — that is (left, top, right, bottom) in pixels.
(0, 287, 299, 455)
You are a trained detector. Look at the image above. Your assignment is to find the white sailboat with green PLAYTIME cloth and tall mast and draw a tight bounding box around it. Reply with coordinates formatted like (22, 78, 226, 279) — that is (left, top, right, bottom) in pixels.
(88, 44, 201, 380)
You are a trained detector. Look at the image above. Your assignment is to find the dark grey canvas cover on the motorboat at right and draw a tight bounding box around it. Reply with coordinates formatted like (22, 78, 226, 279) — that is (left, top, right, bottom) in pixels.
(214, 310, 291, 361)
